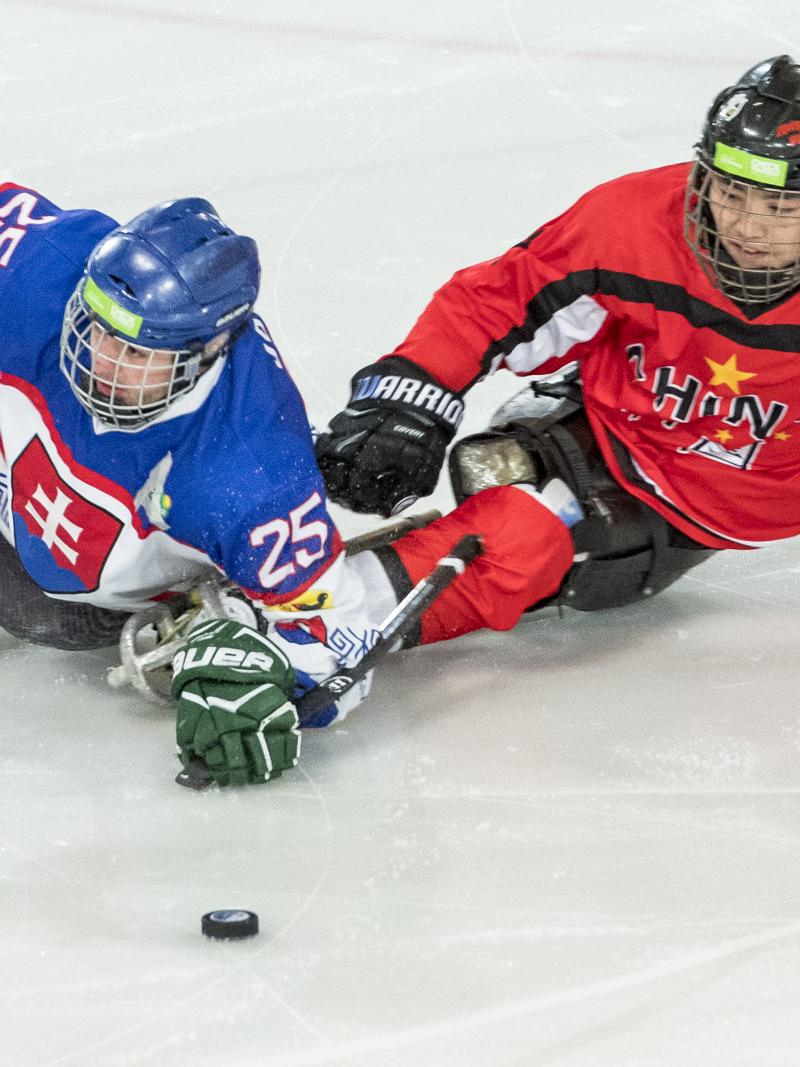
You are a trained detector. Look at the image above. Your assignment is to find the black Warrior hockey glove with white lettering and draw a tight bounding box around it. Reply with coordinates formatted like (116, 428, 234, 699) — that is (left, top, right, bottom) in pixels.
(317, 356, 464, 519)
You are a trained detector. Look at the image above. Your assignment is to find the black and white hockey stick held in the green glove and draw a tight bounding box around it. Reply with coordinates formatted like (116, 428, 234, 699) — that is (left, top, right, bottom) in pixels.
(175, 534, 483, 790)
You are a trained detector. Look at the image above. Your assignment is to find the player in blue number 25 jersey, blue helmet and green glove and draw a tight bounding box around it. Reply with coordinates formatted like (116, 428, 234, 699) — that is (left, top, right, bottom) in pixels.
(0, 185, 407, 784)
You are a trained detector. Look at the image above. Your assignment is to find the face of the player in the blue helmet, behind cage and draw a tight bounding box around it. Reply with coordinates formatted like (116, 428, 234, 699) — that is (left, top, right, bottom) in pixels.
(90, 322, 175, 407)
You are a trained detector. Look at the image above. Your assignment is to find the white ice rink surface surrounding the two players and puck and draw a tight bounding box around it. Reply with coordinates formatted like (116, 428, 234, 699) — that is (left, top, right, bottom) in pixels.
(0, 0, 800, 1067)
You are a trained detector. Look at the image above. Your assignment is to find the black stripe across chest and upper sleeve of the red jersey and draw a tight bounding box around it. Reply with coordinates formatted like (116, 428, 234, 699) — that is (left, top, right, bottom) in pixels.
(467, 269, 800, 387)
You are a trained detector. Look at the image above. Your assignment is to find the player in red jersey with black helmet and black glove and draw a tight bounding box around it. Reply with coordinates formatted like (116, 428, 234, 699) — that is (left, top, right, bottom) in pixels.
(317, 55, 800, 639)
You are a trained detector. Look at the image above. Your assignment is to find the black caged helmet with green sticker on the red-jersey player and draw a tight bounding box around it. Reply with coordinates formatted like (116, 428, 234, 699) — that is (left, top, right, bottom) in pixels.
(685, 55, 800, 304)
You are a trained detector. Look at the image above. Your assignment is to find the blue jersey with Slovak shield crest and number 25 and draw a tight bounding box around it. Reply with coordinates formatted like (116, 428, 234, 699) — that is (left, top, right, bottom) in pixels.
(0, 186, 341, 610)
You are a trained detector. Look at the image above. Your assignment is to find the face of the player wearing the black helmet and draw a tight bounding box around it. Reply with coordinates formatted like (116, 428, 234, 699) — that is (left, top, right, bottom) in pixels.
(708, 175, 800, 271)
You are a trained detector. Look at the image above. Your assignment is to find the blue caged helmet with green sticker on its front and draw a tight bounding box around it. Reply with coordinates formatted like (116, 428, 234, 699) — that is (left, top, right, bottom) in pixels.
(61, 197, 260, 429)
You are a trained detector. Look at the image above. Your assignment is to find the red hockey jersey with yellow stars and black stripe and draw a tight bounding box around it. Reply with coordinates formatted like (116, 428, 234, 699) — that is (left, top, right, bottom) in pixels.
(394, 163, 800, 547)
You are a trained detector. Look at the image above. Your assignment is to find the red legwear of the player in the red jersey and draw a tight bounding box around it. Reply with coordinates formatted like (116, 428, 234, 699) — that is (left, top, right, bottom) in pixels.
(394, 485, 574, 644)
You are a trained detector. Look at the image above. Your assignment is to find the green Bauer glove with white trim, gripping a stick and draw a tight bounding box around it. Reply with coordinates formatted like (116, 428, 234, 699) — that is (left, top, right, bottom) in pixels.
(172, 619, 300, 785)
